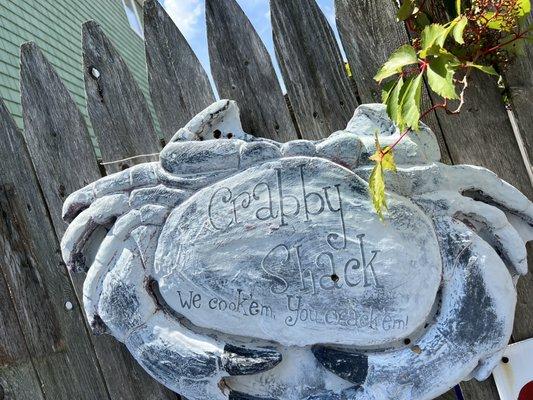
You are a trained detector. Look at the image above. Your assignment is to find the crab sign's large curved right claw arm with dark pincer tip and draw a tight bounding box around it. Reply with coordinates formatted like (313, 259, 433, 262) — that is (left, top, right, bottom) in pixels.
(313, 217, 516, 400)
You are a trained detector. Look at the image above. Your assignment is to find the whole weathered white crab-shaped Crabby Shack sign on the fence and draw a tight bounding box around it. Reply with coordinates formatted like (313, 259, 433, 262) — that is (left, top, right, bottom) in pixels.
(62, 101, 533, 400)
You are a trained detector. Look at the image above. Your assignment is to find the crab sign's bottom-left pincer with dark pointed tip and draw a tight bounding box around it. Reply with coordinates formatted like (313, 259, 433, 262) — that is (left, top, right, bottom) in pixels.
(126, 313, 281, 400)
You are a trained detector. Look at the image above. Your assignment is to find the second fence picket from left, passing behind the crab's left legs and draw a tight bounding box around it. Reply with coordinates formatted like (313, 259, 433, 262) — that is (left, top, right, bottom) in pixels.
(21, 44, 176, 400)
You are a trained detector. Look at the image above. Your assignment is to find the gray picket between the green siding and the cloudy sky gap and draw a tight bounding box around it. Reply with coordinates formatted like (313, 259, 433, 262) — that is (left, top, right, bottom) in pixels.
(144, 0, 215, 141)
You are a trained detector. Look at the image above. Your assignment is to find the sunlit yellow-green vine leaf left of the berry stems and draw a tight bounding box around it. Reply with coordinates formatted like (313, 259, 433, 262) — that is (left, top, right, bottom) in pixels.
(427, 54, 459, 99)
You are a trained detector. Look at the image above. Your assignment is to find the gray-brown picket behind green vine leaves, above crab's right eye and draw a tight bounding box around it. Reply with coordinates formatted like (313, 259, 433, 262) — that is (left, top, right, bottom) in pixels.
(335, 0, 453, 164)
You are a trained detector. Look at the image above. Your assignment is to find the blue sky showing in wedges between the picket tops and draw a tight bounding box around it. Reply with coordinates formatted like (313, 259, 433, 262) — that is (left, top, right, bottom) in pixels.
(159, 0, 335, 91)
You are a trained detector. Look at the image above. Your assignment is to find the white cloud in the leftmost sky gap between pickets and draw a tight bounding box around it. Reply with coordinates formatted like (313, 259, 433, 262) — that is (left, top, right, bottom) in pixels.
(159, 0, 204, 38)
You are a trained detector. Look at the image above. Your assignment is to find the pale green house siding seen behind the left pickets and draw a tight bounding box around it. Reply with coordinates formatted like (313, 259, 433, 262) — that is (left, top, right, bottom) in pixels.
(0, 0, 159, 146)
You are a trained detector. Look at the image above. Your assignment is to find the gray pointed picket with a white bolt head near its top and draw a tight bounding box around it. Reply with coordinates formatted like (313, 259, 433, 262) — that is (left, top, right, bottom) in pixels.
(83, 21, 159, 172)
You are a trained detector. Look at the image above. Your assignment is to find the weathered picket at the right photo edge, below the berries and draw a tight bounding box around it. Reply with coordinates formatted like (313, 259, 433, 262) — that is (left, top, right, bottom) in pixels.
(505, 15, 533, 164)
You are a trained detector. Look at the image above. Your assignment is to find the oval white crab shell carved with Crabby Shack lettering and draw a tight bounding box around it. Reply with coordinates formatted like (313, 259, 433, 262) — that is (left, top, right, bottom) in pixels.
(154, 157, 442, 347)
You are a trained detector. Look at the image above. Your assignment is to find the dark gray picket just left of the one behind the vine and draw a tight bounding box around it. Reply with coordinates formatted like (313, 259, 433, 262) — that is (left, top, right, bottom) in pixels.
(270, 0, 357, 139)
